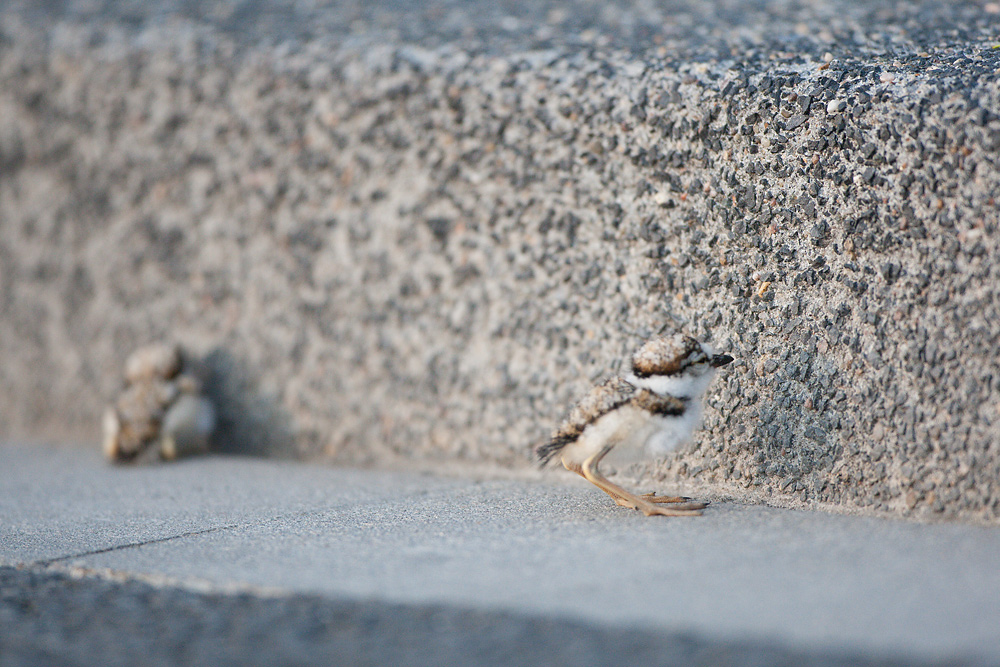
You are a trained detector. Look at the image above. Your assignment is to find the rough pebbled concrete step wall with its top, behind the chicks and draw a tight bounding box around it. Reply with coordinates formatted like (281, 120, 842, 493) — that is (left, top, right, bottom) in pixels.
(0, 0, 1000, 522)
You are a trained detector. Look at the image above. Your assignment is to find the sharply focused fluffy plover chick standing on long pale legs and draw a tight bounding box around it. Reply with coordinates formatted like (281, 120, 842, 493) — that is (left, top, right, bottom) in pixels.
(536, 334, 733, 516)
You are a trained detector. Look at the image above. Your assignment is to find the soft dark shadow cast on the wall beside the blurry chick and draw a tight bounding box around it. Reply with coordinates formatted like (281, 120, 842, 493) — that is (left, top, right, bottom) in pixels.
(197, 348, 297, 458)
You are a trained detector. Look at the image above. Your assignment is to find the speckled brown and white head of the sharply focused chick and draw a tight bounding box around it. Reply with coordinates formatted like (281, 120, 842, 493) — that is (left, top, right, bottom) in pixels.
(626, 334, 733, 398)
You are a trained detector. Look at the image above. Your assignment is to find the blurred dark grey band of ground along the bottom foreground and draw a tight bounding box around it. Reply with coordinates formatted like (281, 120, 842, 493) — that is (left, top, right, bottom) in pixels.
(0, 567, 985, 667)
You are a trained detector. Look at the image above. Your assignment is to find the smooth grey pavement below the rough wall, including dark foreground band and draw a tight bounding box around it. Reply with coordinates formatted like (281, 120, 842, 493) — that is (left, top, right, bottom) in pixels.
(0, 445, 1000, 665)
